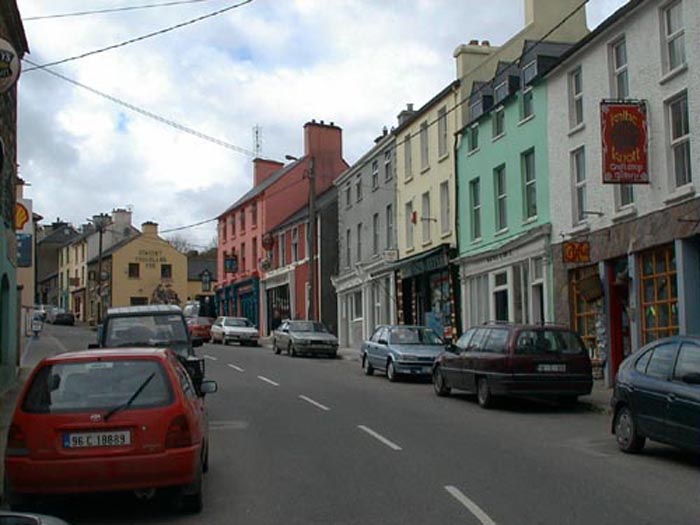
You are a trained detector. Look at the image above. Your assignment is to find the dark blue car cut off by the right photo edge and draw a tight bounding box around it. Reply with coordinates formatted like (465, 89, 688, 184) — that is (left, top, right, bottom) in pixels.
(611, 336, 700, 452)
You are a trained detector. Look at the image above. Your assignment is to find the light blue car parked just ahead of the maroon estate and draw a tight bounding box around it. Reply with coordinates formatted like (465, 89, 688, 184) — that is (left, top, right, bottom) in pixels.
(361, 325, 445, 382)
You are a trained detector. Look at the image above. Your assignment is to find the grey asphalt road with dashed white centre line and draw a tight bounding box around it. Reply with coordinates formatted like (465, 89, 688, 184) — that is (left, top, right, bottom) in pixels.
(16, 327, 700, 525)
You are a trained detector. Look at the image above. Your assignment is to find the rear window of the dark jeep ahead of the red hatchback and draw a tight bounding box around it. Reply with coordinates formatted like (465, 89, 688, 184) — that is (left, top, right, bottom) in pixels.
(105, 315, 187, 347)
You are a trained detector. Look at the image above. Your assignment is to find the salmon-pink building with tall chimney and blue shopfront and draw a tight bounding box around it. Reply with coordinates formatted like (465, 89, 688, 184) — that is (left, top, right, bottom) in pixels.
(217, 121, 347, 334)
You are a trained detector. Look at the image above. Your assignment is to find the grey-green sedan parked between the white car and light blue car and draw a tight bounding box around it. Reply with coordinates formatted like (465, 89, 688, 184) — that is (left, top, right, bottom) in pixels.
(272, 320, 338, 358)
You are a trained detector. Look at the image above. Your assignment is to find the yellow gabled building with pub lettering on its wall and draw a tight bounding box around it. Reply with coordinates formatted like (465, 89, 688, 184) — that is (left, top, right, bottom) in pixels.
(88, 222, 187, 322)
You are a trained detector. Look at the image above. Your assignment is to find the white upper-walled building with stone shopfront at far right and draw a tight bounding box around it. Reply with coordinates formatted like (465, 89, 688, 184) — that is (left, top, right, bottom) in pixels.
(548, 0, 700, 384)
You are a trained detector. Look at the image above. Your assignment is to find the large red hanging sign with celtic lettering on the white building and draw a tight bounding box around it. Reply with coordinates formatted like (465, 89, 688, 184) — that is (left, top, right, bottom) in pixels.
(600, 100, 649, 184)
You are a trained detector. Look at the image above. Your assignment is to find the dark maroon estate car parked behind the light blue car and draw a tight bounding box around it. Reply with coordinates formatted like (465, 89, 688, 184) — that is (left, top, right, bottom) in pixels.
(433, 323, 593, 408)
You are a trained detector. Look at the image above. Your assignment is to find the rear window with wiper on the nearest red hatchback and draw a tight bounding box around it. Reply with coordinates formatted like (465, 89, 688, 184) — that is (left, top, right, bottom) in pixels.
(22, 359, 174, 413)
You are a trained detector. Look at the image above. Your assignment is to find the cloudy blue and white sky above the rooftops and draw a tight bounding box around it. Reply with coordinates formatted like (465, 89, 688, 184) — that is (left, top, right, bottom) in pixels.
(17, 0, 626, 250)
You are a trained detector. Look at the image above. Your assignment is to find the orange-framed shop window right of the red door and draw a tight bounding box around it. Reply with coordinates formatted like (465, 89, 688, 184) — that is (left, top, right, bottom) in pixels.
(639, 245, 678, 344)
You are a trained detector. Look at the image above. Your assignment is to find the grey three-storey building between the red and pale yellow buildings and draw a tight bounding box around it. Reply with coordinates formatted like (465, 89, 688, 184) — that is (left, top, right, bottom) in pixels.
(332, 128, 397, 346)
